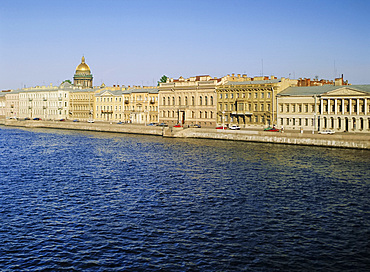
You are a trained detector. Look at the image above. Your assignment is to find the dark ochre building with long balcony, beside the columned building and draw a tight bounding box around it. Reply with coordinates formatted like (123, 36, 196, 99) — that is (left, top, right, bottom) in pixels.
(216, 74, 297, 127)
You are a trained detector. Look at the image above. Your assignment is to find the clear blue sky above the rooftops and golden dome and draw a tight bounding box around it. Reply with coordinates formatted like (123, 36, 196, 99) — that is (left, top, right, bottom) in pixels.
(0, 0, 370, 90)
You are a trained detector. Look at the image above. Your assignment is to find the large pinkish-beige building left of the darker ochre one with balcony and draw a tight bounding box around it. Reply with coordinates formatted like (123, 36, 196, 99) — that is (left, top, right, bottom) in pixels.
(159, 75, 224, 127)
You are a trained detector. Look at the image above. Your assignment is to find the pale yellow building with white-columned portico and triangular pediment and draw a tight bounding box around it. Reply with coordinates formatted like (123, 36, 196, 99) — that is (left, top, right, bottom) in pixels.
(277, 85, 370, 132)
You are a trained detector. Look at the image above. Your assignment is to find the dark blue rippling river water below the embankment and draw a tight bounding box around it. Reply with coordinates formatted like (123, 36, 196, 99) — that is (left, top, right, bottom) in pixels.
(0, 127, 370, 271)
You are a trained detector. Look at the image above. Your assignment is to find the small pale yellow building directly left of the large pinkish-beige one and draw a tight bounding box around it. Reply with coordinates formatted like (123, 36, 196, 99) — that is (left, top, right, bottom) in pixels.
(123, 86, 159, 124)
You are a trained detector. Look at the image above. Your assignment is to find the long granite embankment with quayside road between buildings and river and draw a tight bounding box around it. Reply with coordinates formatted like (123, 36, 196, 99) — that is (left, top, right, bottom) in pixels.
(0, 120, 370, 149)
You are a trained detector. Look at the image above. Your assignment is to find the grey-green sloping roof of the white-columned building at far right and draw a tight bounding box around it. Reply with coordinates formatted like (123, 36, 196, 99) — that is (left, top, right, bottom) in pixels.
(278, 85, 370, 96)
